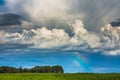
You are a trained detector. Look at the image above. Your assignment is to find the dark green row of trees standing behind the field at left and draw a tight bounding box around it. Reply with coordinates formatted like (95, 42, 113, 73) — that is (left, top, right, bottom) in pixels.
(0, 65, 64, 73)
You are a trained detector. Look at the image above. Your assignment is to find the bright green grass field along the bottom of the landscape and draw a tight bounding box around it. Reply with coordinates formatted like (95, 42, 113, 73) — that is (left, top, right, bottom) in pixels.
(0, 73, 120, 80)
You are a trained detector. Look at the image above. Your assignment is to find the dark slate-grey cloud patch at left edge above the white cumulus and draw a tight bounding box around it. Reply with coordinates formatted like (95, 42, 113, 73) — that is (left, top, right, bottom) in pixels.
(0, 13, 37, 33)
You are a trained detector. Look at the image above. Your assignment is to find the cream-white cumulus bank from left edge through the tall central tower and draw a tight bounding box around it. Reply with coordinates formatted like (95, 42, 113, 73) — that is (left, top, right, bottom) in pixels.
(0, 19, 100, 50)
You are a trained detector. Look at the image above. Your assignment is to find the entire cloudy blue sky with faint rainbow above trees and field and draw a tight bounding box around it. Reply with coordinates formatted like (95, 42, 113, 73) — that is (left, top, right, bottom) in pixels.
(0, 0, 120, 73)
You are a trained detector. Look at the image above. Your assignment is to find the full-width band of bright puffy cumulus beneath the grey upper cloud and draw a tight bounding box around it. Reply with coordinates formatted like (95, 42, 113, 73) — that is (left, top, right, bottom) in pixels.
(0, 19, 120, 55)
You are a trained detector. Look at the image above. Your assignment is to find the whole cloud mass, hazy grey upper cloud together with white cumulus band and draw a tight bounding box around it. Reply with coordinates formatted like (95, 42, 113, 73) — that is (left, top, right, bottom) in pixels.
(0, 0, 120, 55)
